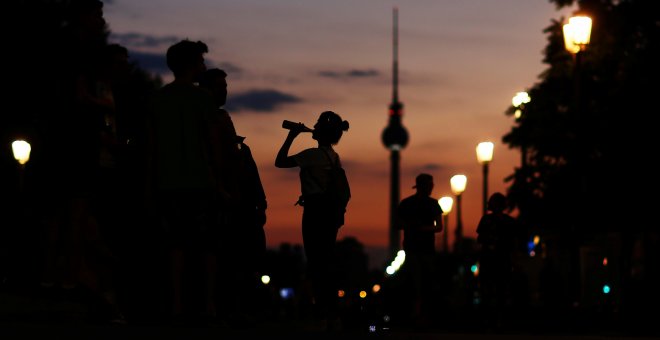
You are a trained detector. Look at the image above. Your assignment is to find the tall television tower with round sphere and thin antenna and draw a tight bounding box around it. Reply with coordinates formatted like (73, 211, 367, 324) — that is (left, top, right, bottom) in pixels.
(381, 7, 408, 258)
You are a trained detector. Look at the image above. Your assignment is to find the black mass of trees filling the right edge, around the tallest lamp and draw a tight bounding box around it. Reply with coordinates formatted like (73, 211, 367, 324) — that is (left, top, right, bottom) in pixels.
(503, 0, 660, 330)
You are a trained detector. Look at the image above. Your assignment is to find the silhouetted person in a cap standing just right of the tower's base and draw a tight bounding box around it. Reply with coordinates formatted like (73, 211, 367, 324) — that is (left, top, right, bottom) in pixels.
(397, 173, 443, 323)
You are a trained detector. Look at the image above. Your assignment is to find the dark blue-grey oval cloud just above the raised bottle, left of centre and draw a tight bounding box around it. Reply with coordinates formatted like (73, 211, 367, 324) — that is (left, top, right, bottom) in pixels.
(225, 90, 302, 113)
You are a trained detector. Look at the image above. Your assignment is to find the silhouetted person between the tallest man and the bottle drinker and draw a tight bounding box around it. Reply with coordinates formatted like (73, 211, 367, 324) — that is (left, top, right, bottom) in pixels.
(199, 68, 267, 325)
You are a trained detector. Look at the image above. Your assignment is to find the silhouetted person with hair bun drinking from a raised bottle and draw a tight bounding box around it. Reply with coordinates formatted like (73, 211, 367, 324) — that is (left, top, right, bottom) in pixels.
(275, 111, 349, 330)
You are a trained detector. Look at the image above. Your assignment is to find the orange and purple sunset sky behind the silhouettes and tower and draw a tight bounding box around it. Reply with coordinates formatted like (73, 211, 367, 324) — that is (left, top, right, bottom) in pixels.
(104, 0, 571, 252)
